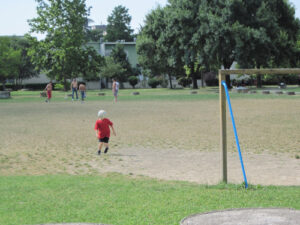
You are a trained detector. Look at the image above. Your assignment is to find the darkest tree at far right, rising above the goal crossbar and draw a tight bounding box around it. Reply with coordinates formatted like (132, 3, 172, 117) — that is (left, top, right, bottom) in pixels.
(232, 0, 300, 87)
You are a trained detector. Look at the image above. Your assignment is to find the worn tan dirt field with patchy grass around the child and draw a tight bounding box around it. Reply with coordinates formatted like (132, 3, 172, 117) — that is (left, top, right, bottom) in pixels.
(0, 99, 300, 185)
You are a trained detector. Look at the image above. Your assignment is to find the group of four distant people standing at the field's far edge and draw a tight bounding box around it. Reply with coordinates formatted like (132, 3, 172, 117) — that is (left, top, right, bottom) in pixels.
(44, 79, 119, 102)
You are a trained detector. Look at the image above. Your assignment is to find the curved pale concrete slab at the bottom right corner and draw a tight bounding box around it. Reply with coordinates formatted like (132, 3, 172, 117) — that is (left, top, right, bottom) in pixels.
(180, 208, 300, 225)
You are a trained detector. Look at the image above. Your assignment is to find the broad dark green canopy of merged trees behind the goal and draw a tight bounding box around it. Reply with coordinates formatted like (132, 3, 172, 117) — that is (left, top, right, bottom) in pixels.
(137, 0, 300, 88)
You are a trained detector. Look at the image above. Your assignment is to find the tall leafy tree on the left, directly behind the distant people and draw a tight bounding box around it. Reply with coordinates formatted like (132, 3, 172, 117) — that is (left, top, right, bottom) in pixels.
(28, 0, 100, 90)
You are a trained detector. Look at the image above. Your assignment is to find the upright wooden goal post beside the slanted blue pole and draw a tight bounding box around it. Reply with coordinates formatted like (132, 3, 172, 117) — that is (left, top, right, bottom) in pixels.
(219, 70, 227, 183)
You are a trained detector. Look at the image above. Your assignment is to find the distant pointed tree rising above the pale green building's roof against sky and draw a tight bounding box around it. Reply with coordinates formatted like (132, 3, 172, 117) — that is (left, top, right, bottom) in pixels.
(105, 5, 133, 41)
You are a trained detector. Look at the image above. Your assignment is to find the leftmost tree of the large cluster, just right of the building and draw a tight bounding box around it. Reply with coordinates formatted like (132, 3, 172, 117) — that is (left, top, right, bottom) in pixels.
(137, 7, 184, 88)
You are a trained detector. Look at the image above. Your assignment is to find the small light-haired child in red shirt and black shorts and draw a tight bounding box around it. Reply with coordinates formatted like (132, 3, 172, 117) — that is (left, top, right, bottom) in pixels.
(95, 110, 116, 155)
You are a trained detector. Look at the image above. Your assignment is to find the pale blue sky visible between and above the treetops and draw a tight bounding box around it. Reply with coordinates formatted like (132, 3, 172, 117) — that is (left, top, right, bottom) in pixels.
(0, 0, 300, 37)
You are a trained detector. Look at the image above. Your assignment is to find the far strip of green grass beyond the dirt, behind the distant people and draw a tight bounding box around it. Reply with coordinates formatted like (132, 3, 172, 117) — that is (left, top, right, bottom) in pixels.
(0, 86, 300, 103)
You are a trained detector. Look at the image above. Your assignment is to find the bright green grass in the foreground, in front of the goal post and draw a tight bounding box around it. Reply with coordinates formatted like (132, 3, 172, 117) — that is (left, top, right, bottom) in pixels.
(0, 174, 300, 225)
